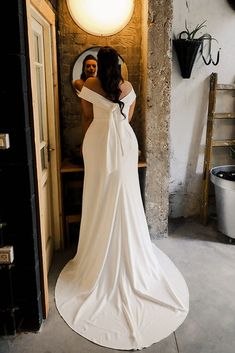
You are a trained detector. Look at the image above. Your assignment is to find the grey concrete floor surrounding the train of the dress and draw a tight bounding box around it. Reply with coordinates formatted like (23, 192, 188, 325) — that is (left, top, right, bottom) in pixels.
(0, 219, 235, 353)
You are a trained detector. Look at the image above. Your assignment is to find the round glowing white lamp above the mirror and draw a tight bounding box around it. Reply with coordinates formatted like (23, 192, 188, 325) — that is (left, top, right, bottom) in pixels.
(67, 0, 134, 36)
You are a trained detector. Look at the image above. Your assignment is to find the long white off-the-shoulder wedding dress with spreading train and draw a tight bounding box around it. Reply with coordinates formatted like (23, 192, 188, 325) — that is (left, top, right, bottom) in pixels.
(55, 87, 189, 350)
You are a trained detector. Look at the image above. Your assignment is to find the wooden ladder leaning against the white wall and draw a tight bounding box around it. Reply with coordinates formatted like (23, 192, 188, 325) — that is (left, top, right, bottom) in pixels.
(201, 72, 235, 225)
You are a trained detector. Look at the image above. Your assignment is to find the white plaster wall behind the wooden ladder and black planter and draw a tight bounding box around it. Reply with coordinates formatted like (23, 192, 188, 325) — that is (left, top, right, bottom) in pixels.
(169, 0, 235, 217)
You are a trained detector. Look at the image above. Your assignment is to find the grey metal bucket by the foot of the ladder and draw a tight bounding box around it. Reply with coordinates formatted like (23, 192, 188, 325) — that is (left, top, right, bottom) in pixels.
(210, 165, 235, 238)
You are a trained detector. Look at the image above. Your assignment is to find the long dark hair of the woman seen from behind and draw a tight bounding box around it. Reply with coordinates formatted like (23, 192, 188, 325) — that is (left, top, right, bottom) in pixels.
(97, 46, 125, 116)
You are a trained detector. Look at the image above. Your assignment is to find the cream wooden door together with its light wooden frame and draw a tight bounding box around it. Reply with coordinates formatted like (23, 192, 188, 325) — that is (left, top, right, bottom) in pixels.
(27, 1, 62, 317)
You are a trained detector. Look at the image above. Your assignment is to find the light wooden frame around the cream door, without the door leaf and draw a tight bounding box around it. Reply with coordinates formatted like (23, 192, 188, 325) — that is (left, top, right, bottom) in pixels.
(26, 0, 63, 317)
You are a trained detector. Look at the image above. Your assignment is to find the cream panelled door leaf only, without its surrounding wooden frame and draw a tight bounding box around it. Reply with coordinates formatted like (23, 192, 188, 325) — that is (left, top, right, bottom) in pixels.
(32, 13, 53, 266)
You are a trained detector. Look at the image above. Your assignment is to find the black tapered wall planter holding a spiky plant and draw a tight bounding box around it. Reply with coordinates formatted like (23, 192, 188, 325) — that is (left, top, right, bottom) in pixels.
(173, 39, 203, 78)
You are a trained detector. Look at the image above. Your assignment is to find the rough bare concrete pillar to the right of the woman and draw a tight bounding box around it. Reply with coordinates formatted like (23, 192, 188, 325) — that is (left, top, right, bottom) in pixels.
(144, 0, 172, 237)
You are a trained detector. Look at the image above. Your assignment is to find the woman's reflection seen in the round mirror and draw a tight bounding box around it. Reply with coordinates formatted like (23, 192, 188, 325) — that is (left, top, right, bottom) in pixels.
(73, 54, 97, 93)
